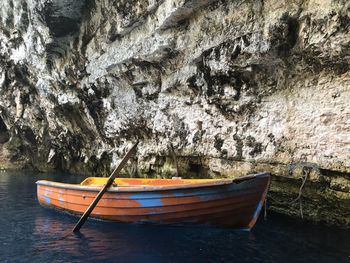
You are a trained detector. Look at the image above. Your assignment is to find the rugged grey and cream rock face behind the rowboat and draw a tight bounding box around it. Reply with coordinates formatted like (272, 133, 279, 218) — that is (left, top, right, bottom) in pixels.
(0, 0, 350, 225)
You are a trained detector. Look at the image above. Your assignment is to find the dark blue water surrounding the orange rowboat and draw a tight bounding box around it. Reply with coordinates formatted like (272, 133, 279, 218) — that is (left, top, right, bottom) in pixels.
(0, 171, 350, 263)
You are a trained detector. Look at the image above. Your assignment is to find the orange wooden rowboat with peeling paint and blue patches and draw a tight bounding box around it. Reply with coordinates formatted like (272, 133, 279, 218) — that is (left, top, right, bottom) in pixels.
(37, 173, 270, 229)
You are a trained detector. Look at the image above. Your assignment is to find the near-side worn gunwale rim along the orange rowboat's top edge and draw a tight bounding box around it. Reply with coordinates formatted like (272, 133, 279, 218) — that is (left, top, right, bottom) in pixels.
(36, 172, 270, 193)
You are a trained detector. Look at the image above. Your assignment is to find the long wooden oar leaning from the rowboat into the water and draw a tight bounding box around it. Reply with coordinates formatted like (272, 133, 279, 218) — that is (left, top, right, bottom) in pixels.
(72, 142, 139, 233)
